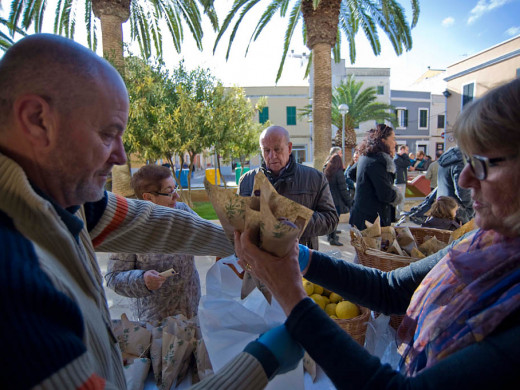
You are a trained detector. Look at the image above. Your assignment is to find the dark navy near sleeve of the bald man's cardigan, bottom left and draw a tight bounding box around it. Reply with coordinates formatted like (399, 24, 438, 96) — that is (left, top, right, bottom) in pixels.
(0, 212, 105, 389)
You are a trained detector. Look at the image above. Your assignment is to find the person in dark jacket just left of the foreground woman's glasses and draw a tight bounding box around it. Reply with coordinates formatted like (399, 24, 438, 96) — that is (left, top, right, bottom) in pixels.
(437, 146, 475, 223)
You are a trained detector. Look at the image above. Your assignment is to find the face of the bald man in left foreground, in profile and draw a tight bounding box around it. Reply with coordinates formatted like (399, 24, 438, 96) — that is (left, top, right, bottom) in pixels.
(47, 75, 129, 207)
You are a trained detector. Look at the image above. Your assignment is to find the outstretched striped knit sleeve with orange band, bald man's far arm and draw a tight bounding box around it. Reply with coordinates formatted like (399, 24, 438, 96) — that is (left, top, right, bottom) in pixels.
(85, 192, 233, 257)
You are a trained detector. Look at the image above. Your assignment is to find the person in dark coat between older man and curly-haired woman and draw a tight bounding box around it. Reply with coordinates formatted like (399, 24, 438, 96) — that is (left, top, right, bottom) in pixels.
(324, 154, 350, 246)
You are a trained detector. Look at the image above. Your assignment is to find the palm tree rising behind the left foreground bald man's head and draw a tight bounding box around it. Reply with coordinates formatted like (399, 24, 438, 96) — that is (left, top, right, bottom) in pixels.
(4, 0, 218, 70)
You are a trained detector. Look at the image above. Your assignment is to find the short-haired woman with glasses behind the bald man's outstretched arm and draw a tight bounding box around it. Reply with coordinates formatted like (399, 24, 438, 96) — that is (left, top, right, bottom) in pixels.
(105, 164, 201, 323)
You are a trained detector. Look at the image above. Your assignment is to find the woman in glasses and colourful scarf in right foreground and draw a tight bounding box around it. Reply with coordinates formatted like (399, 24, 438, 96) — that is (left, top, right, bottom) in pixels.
(230, 79, 520, 390)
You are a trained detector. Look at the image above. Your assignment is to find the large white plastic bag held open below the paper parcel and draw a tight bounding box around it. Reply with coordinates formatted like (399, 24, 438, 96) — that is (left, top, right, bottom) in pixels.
(198, 256, 304, 390)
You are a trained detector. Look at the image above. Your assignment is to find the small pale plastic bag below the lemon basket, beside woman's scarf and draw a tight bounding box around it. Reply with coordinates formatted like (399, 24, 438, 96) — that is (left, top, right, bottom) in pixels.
(365, 312, 401, 370)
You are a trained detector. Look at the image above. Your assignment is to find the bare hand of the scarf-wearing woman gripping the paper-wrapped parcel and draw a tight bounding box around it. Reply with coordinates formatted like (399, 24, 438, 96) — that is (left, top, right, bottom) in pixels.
(235, 230, 307, 315)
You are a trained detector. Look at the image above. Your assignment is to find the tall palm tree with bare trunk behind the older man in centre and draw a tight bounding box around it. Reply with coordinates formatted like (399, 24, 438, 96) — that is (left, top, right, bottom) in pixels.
(214, 0, 419, 168)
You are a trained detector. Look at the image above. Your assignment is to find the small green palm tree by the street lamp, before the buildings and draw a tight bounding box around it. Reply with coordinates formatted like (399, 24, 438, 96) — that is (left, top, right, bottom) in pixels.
(332, 75, 397, 163)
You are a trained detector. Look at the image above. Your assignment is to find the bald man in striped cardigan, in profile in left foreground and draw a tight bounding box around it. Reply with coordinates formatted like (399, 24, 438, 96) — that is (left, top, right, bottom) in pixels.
(0, 34, 242, 389)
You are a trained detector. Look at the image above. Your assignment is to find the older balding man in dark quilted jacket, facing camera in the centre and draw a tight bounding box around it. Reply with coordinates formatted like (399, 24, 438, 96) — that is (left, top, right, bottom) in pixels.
(238, 126, 339, 249)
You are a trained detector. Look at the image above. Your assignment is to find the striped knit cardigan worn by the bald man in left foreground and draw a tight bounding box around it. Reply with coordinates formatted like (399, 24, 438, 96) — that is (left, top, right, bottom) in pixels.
(0, 154, 233, 389)
